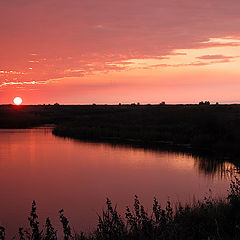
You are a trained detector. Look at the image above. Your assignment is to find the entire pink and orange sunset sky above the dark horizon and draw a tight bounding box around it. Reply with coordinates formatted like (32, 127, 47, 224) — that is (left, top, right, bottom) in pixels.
(0, 0, 240, 104)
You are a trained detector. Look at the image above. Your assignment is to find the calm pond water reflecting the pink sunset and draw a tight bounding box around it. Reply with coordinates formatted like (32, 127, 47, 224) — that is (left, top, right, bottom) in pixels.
(0, 128, 237, 235)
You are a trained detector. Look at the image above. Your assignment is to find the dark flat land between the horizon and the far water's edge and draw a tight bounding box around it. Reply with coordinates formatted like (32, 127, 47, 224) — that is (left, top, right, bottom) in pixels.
(0, 105, 240, 157)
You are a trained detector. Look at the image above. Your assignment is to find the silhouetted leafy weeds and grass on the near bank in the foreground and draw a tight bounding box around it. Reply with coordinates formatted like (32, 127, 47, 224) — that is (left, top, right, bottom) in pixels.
(0, 178, 240, 240)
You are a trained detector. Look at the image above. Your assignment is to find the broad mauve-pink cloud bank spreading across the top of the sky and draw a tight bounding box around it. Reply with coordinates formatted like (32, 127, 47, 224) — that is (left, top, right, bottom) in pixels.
(0, 0, 240, 85)
